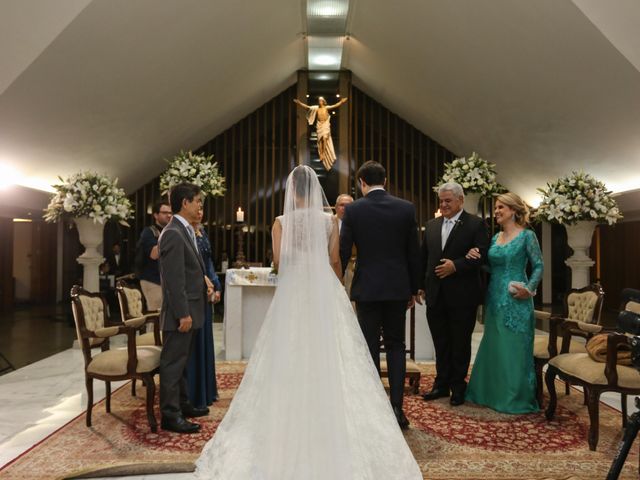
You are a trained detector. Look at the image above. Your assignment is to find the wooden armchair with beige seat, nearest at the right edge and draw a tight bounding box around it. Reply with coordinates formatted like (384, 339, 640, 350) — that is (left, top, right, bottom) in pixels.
(545, 292, 640, 450)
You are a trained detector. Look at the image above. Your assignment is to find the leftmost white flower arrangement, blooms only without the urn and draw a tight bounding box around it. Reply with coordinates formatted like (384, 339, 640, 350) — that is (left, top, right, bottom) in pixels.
(44, 172, 132, 227)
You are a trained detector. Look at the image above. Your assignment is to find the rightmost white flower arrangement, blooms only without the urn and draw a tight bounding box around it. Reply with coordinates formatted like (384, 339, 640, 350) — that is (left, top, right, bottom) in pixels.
(535, 172, 622, 225)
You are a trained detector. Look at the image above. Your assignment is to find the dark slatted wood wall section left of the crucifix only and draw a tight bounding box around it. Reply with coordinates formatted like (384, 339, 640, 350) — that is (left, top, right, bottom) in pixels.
(128, 85, 296, 268)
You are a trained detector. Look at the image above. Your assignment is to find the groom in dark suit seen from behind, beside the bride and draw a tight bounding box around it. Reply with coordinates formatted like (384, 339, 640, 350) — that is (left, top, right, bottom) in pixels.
(340, 161, 419, 429)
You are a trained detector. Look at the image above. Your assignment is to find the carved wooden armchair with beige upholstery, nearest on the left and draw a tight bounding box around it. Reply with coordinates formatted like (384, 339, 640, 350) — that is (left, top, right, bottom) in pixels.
(71, 285, 160, 433)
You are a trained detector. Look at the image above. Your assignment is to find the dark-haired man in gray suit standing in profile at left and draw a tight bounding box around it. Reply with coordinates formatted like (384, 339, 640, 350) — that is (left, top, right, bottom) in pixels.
(158, 183, 209, 433)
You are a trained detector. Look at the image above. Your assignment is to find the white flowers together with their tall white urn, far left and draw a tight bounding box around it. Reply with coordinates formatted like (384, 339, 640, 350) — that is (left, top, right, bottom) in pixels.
(44, 172, 132, 292)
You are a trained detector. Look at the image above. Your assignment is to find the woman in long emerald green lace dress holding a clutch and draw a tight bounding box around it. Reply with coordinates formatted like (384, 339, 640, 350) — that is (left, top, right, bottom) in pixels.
(466, 192, 542, 413)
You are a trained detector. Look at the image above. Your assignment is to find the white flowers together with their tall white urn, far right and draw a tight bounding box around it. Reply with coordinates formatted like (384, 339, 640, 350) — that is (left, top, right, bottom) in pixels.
(535, 172, 622, 288)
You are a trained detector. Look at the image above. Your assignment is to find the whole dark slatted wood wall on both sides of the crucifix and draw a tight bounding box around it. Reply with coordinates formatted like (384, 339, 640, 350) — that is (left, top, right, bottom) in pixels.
(127, 81, 454, 268)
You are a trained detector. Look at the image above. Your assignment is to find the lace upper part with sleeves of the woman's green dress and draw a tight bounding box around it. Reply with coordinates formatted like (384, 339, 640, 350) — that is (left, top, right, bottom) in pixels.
(487, 230, 543, 333)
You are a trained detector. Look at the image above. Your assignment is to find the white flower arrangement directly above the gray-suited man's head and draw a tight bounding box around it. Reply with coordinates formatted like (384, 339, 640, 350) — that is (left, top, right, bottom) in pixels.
(160, 151, 226, 197)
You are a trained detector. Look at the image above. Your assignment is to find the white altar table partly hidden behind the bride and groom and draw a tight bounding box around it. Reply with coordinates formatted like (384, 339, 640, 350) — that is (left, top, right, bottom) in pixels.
(223, 268, 435, 361)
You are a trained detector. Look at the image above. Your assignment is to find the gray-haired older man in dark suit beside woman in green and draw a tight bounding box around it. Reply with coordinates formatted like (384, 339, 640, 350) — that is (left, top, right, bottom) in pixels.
(418, 182, 489, 406)
